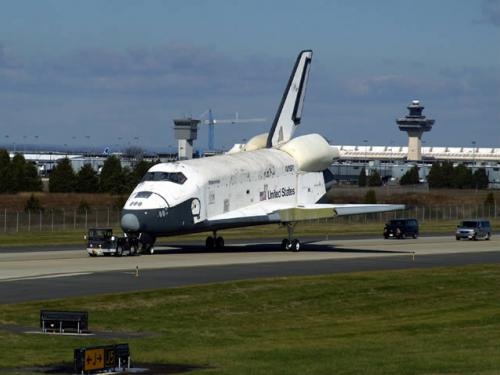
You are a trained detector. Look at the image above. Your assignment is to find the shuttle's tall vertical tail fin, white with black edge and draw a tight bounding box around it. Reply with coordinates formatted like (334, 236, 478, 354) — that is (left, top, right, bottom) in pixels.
(267, 50, 312, 148)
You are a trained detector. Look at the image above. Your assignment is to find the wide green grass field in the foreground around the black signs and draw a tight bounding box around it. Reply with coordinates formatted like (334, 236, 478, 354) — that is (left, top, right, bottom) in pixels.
(0, 265, 500, 375)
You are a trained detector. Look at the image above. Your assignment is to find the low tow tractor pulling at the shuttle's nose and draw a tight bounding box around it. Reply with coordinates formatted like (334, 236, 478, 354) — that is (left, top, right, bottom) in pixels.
(84, 228, 139, 257)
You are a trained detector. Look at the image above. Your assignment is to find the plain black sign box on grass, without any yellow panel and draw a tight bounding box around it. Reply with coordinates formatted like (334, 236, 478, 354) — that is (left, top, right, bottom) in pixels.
(40, 310, 89, 333)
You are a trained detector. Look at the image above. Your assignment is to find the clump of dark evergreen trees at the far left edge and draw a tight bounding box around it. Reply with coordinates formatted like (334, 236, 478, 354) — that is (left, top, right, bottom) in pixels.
(0, 149, 42, 194)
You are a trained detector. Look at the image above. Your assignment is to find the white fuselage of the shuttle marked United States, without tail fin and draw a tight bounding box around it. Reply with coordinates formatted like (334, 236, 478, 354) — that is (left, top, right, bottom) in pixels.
(120, 149, 325, 235)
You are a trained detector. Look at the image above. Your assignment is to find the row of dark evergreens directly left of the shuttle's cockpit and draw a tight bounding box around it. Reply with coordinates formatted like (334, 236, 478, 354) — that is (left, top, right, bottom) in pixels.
(49, 155, 156, 194)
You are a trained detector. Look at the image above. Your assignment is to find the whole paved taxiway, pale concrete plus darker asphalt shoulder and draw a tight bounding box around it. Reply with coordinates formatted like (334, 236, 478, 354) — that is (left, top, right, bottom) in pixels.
(0, 236, 500, 303)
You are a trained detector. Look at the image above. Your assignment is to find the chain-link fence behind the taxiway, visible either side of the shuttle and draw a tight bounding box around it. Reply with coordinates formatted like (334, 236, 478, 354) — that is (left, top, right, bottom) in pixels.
(0, 205, 500, 233)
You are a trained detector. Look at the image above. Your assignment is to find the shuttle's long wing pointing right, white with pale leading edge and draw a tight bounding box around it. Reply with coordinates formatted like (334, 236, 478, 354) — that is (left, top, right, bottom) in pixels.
(208, 202, 405, 224)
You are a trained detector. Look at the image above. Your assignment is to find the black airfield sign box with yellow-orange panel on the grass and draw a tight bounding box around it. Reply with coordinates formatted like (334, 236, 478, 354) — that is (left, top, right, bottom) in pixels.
(74, 344, 130, 374)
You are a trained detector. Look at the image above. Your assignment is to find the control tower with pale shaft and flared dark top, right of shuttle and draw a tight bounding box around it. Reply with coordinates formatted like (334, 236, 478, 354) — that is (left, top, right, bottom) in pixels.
(396, 100, 434, 161)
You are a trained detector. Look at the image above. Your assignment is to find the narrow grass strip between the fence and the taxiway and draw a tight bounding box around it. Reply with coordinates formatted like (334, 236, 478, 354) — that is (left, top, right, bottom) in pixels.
(0, 219, 500, 251)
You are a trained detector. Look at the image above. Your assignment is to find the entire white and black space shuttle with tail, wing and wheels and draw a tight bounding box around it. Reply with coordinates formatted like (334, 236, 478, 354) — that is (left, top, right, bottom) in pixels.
(121, 50, 404, 254)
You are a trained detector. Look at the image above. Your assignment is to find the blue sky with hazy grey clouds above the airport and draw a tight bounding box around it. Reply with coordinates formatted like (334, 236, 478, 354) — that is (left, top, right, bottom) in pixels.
(0, 0, 500, 151)
